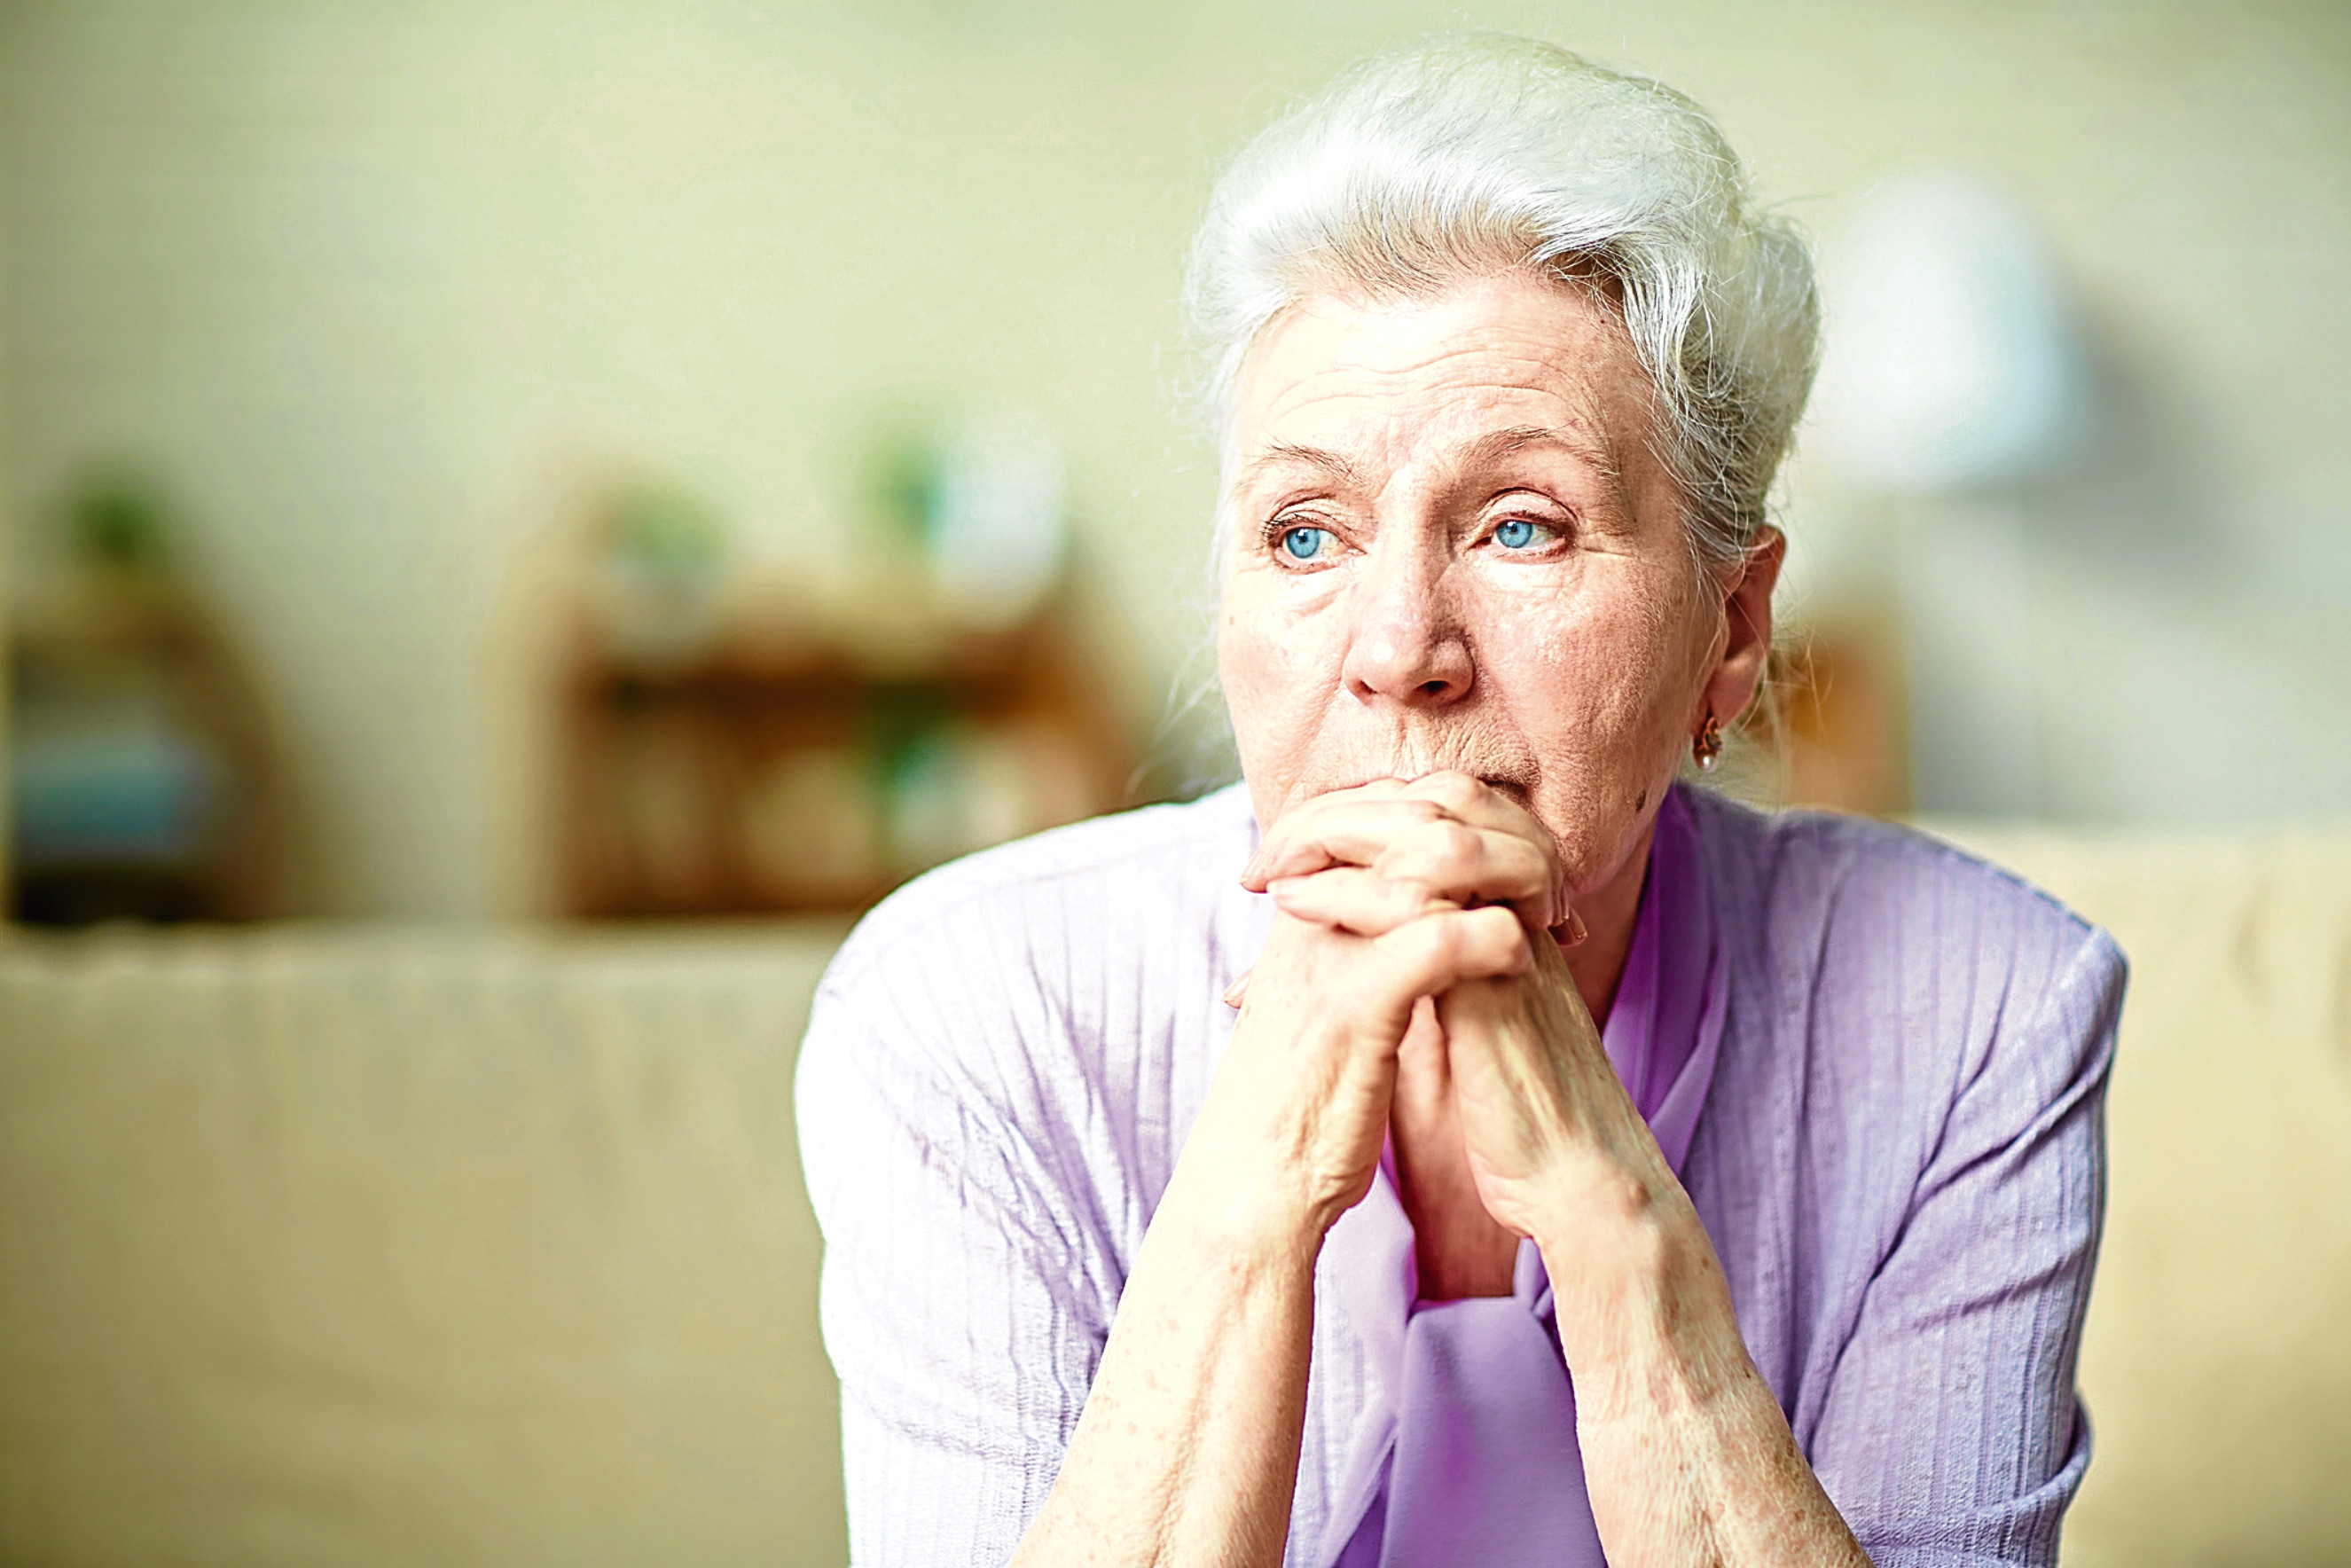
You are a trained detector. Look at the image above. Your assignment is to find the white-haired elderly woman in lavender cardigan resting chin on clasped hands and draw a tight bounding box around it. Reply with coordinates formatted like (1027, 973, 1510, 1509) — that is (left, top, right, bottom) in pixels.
(799, 40, 2123, 1568)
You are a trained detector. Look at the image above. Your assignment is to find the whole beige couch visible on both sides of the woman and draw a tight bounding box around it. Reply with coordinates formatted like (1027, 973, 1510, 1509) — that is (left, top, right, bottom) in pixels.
(0, 830, 2351, 1568)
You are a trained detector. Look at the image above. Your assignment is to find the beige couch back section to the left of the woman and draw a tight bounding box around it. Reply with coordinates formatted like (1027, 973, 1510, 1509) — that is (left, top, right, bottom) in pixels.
(0, 929, 846, 1568)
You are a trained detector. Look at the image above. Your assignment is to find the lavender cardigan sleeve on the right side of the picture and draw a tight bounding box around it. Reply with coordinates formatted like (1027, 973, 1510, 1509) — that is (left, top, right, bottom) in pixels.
(1810, 931, 2126, 1568)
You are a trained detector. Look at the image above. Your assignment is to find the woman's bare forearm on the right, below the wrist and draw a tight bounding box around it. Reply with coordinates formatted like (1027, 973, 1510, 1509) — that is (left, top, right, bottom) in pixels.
(1538, 1206, 1869, 1568)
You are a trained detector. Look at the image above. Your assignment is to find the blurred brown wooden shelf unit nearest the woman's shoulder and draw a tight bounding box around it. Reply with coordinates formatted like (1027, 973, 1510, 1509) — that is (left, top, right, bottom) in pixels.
(562, 614, 1131, 917)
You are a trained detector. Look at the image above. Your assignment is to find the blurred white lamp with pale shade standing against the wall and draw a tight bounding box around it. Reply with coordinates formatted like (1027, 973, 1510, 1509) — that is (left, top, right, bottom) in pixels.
(1810, 174, 2090, 816)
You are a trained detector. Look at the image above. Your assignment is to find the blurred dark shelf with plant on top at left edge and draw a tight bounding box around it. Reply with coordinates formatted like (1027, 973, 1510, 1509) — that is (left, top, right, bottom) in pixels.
(10, 474, 289, 924)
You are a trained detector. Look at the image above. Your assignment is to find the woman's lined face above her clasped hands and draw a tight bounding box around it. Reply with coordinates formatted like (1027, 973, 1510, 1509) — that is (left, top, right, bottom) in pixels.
(1218, 272, 1744, 982)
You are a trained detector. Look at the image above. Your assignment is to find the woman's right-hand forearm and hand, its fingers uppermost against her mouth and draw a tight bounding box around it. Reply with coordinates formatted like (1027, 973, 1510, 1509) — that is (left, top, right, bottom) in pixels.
(1243, 773, 1869, 1568)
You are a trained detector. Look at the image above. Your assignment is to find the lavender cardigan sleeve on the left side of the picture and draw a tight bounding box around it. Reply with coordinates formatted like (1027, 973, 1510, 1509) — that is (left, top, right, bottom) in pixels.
(795, 931, 1117, 1568)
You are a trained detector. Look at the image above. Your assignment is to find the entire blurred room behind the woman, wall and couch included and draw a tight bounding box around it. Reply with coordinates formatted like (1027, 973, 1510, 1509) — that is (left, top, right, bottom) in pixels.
(0, 0, 2351, 1564)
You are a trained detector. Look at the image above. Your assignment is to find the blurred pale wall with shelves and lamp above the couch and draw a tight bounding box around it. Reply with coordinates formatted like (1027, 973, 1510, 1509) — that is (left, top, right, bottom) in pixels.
(0, 0, 2351, 917)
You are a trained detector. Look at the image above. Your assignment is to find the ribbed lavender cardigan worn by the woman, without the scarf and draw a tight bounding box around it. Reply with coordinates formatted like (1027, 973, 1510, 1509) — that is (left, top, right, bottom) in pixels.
(797, 788, 2123, 1568)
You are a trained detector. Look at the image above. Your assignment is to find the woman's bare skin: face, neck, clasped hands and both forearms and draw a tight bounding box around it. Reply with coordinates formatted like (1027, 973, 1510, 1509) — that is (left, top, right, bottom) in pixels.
(1015, 275, 1867, 1568)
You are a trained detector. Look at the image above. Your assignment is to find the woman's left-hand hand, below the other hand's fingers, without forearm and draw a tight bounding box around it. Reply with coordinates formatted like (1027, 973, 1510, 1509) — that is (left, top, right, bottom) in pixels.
(1178, 906, 1531, 1243)
